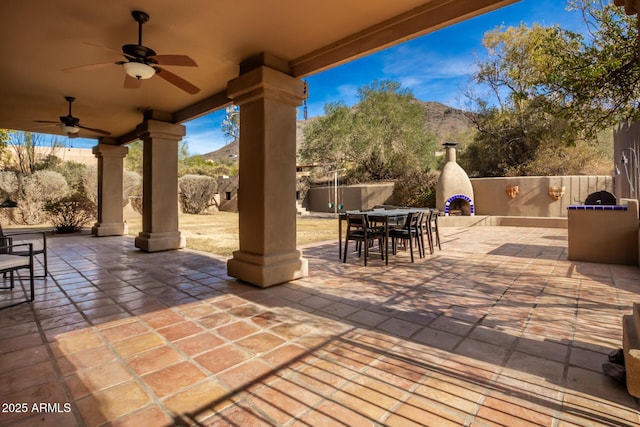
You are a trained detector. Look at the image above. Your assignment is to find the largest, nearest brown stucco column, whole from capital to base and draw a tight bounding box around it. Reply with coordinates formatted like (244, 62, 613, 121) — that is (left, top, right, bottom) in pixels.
(227, 66, 308, 287)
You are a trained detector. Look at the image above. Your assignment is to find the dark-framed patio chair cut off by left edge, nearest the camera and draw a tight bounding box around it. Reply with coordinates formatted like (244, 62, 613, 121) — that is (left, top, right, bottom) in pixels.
(0, 237, 35, 310)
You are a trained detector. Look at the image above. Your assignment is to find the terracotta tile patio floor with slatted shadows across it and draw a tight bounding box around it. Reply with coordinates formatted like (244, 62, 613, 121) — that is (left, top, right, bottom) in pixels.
(0, 227, 640, 427)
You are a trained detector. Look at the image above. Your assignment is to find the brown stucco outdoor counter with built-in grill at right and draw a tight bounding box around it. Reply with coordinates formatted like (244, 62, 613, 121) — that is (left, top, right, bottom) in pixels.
(567, 199, 639, 265)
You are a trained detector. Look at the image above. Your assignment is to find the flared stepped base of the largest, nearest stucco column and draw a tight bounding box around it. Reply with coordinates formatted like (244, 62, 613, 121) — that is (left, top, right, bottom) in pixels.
(227, 250, 309, 288)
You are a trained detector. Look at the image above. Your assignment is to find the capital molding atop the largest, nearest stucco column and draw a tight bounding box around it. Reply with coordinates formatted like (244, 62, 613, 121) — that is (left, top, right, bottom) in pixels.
(227, 66, 306, 106)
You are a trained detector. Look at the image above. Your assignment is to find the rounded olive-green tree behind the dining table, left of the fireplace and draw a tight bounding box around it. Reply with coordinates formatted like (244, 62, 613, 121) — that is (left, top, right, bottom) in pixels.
(300, 81, 435, 182)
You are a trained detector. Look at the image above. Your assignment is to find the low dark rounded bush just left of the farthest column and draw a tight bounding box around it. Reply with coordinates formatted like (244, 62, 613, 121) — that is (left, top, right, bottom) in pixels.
(44, 193, 96, 233)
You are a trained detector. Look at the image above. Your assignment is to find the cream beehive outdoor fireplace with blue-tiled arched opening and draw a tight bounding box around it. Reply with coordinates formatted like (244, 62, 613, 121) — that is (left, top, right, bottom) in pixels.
(436, 142, 475, 216)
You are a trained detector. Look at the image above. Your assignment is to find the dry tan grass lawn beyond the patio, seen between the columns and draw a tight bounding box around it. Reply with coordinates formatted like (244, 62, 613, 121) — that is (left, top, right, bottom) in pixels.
(126, 212, 338, 257)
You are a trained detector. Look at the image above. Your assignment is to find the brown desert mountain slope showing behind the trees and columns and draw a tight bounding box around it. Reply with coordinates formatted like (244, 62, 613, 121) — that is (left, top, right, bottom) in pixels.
(202, 101, 474, 161)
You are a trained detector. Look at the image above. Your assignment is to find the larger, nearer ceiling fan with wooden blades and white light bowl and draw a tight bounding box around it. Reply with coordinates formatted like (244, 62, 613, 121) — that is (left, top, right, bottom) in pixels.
(65, 10, 200, 95)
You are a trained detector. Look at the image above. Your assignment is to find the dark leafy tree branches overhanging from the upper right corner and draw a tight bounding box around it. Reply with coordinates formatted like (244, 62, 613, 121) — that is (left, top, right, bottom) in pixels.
(544, 0, 640, 135)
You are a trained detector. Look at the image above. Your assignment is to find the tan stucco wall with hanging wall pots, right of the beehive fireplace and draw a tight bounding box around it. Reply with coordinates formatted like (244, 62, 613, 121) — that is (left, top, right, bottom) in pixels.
(471, 175, 613, 217)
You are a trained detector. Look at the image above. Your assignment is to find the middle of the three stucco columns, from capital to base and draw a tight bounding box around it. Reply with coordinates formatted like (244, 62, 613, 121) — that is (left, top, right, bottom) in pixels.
(135, 120, 186, 252)
